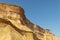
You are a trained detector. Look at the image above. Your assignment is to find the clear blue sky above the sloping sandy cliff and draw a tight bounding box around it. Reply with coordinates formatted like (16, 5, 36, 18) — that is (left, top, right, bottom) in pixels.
(0, 0, 60, 36)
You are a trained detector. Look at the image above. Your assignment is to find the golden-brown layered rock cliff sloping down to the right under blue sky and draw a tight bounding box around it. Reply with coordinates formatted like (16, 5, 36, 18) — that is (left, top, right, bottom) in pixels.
(0, 3, 57, 40)
